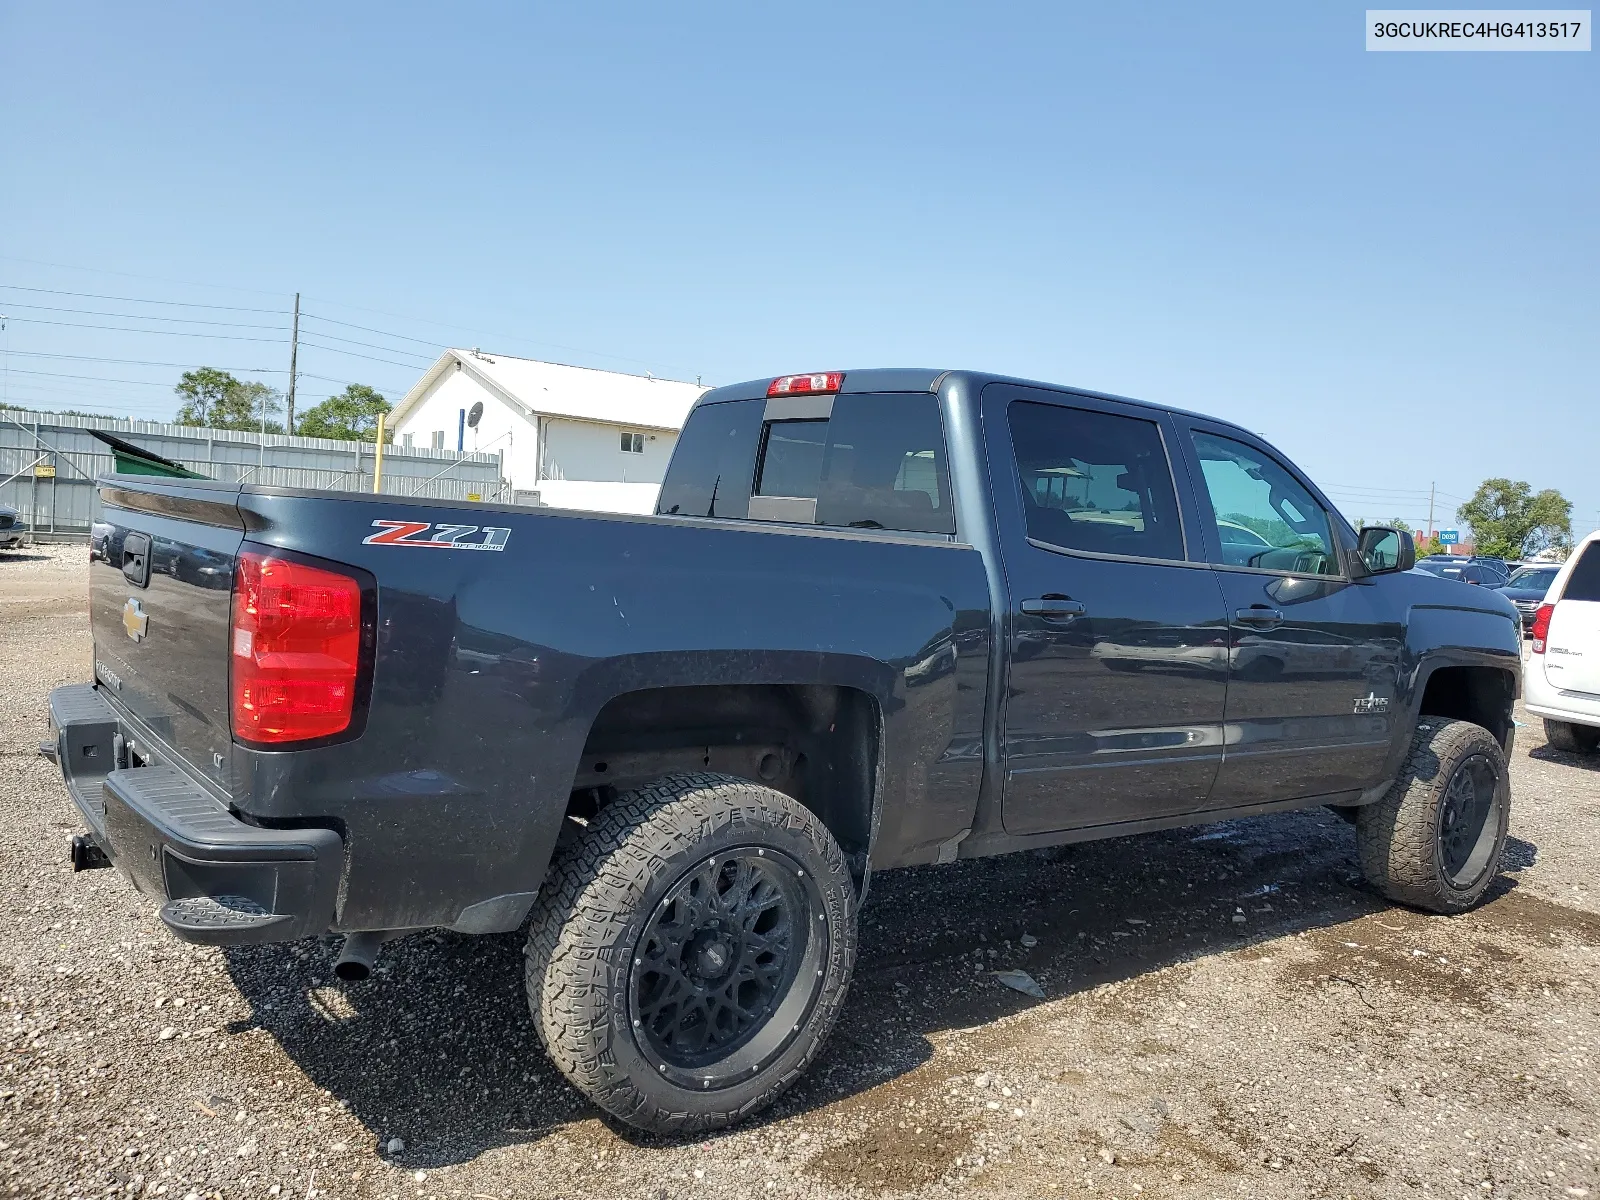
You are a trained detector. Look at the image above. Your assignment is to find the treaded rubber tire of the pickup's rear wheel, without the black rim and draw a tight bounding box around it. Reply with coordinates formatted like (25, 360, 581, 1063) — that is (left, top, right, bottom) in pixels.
(525, 771, 856, 1136)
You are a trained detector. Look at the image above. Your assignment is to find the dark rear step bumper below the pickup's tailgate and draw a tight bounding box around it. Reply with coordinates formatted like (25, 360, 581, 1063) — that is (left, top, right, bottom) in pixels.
(46, 685, 344, 946)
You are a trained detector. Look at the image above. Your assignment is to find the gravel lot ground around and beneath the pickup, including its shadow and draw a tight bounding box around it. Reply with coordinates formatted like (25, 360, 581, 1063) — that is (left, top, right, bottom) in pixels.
(0, 546, 1600, 1200)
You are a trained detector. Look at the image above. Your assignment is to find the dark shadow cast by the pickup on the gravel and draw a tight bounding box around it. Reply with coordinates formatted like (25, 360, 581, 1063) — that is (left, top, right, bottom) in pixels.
(226, 810, 1538, 1168)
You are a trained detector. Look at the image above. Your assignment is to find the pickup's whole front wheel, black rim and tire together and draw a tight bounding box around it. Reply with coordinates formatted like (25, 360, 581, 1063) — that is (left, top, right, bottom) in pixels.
(1355, 717, 1510, 912)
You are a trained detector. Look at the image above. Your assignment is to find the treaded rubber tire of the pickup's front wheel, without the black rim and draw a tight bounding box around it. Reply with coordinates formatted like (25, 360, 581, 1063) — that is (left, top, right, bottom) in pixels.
(1355, 717, 1510, 912)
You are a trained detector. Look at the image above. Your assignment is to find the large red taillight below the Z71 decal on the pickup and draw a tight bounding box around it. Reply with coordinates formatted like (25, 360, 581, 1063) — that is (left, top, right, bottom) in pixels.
(230, 550, 362, 744)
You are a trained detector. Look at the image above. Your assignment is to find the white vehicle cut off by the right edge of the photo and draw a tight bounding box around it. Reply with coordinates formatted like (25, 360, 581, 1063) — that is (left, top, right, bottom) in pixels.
(1523, 530, 1600, 754)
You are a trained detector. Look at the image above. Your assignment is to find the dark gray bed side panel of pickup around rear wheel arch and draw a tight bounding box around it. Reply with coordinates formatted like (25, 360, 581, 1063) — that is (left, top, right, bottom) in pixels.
(235, 493, 989, 930)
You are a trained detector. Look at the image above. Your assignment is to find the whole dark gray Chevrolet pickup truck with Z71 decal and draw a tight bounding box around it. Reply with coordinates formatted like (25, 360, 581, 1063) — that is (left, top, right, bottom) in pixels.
(43, 370, 1520, 1133)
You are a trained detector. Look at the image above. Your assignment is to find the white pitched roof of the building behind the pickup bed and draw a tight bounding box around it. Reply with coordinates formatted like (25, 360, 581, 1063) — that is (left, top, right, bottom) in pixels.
(389, 349, 710, 430)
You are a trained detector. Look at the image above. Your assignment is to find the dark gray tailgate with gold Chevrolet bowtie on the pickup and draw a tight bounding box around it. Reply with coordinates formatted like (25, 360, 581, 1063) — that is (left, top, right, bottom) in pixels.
(90, 482, 245, 790)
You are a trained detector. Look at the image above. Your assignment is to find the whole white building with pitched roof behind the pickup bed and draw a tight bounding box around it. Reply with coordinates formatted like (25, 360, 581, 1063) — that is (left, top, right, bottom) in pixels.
(389, 350, 707, 512)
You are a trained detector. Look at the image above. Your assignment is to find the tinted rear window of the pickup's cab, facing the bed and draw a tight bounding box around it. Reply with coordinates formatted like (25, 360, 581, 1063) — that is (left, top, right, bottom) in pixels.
(656, 392, 955, 534)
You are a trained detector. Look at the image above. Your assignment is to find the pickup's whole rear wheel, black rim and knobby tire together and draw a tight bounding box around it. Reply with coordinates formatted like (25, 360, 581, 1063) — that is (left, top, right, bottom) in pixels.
(526, 773, 856, 1134)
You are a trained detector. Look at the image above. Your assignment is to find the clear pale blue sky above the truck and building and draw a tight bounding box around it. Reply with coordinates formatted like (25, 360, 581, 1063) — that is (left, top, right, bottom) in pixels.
(0, 3, 1600, 531)
